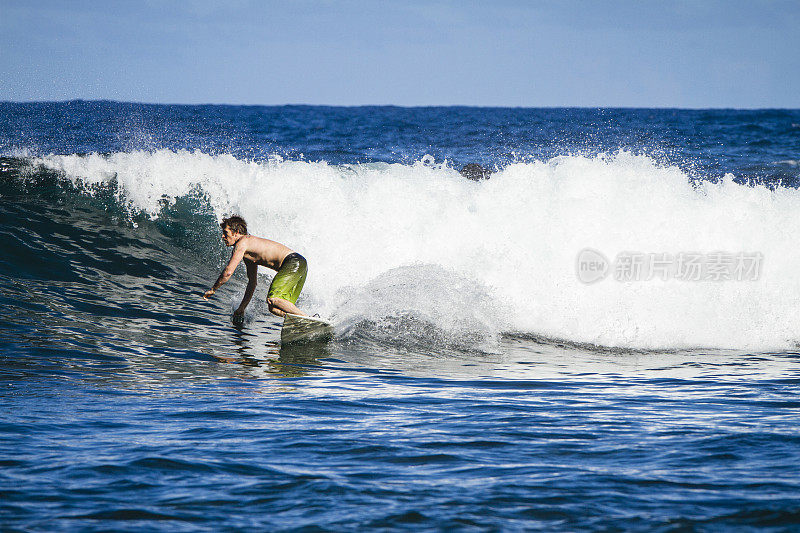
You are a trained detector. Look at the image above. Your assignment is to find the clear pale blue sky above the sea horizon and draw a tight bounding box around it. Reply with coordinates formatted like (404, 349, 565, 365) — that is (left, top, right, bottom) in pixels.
(0, 0, 800, 108)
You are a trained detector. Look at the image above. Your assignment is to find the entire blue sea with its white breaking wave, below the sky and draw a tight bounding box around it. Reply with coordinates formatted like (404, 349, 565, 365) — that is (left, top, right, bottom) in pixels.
(0, 101, 800, 531)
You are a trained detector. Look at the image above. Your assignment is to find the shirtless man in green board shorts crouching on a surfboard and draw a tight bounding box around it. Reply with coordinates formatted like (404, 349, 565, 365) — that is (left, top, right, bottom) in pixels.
(203, 215, 308, 319)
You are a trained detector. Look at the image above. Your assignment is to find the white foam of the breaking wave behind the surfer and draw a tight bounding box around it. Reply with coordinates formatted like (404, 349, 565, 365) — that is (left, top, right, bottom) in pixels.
(31, 150, 800, 350)
